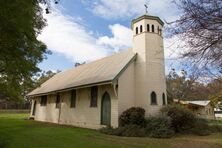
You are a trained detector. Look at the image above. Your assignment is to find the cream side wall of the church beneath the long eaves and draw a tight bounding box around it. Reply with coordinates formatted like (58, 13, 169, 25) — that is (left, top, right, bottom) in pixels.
(30, 84, 118, 129)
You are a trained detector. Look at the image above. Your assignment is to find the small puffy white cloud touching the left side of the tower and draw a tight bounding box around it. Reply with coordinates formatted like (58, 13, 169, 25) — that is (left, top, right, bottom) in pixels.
(97, 24, 132, 52)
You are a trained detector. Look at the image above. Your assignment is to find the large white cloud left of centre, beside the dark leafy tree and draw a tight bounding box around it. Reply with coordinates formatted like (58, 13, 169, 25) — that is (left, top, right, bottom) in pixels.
(38, 7, 111, 62)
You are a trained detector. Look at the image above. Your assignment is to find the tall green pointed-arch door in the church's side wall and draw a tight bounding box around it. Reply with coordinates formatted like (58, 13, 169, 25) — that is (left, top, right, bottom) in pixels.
(101, 92, 111, 125)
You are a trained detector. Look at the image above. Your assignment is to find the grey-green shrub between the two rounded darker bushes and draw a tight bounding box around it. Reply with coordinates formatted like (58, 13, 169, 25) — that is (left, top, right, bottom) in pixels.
(146, 116, 174, 138)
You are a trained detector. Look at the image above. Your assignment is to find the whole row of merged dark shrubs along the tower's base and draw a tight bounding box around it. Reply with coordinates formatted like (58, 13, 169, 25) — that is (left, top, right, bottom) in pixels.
(100, 105, 222, 138)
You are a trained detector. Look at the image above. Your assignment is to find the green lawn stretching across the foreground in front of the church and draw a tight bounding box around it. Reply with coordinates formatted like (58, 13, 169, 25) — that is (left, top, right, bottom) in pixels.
(0, 113, 222, 148)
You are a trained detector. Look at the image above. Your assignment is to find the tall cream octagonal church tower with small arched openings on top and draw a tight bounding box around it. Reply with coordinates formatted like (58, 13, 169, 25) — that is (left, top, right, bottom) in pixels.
(131, 14, 167, 116)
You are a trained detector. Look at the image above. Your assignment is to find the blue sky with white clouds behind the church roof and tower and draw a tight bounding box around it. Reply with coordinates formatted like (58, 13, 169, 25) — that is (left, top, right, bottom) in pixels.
(38, 0, 180, 71)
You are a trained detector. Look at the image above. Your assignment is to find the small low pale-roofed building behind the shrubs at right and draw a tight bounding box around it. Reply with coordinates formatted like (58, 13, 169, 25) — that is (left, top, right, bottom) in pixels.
(174, 99, 215, 119)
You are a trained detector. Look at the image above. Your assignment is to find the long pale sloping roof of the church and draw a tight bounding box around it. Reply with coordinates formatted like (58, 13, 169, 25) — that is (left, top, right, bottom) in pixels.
(27, 50, 136, 96)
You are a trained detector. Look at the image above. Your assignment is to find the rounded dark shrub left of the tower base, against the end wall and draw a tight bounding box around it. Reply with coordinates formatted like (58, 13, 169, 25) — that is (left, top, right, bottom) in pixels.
(119, 107, 146, 127)
